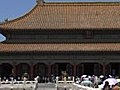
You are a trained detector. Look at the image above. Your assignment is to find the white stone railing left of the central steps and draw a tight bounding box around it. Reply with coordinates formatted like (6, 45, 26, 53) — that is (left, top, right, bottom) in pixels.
(0, 81, 38, 90)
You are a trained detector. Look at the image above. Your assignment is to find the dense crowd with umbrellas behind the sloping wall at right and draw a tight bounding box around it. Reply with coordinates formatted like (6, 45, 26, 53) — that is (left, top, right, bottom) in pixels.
(75, 75, 120, 90)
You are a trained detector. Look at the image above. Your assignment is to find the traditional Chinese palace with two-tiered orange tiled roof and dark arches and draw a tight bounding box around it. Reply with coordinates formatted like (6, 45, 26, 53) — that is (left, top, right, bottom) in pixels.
(0, 0, 120, 79)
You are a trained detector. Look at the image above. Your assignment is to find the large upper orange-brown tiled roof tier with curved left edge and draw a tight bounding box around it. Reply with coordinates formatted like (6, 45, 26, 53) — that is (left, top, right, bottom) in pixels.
(0, 2, 120, 29)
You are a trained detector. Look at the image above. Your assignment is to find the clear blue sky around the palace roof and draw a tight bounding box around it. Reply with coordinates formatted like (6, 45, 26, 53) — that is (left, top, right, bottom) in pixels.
(0, 0, 120, 41)
